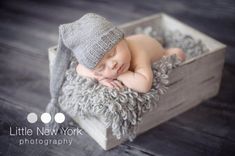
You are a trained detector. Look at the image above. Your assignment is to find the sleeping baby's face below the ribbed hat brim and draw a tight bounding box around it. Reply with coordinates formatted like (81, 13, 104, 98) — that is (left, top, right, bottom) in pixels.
(93, 39, 131, 79)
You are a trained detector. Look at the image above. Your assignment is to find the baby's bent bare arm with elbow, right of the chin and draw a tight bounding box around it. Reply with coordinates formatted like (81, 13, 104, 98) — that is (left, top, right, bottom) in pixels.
(117, 65, 153, 93)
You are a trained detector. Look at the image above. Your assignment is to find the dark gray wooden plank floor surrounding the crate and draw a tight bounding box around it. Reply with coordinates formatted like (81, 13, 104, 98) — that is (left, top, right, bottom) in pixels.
(0, 0, 235, 156)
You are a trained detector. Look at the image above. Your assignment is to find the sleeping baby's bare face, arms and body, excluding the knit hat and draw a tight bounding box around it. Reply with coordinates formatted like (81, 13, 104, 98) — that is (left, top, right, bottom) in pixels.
(76, 34, 185, 93)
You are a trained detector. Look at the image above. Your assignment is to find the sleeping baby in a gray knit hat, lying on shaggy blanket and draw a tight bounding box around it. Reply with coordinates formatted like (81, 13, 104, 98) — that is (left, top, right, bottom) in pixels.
(73, 13, 185, 93)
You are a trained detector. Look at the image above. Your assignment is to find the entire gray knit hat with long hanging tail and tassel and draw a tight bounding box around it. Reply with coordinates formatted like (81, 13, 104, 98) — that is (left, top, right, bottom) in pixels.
(46, 13, 124, 131)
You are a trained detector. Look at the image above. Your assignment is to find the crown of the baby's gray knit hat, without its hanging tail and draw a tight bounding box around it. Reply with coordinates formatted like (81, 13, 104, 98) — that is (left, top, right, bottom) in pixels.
(60, 13, 124, 69)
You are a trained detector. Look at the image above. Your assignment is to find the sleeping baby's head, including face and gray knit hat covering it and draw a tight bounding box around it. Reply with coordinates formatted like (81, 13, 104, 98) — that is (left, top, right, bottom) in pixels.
(71, 13, 131, 78)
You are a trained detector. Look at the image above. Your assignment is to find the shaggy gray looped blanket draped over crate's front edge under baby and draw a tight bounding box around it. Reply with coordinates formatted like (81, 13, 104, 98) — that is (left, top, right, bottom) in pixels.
(59, 55, 180, 141)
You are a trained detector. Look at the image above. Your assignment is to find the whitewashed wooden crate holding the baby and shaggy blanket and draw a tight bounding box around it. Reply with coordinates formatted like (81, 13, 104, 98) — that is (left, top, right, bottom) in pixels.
(49, 13, 226, 150)
